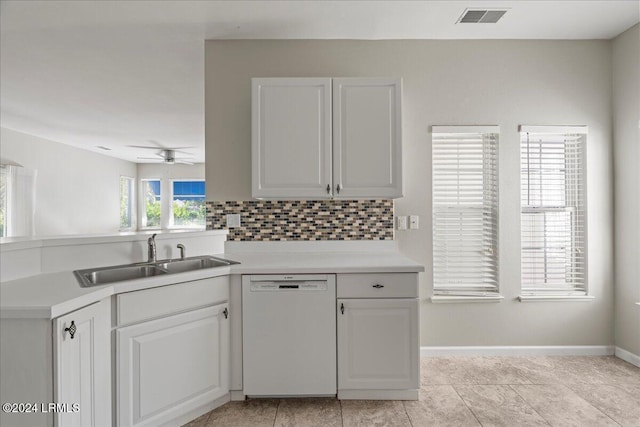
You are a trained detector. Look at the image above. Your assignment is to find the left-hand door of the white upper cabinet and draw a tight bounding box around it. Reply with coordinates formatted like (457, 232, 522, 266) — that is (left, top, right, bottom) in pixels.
(251, 78, 331, 198)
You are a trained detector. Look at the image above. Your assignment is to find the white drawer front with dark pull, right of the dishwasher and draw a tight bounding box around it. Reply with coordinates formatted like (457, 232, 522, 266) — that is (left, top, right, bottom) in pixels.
(337, 273, 418, 298)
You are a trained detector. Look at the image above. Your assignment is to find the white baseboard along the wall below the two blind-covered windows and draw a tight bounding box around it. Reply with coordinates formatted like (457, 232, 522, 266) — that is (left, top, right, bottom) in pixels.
(420, 345, 616, 360)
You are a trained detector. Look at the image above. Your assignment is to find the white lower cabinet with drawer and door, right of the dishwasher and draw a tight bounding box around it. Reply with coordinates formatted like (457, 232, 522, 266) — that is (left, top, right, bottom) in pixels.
(336, 274, 420, 400)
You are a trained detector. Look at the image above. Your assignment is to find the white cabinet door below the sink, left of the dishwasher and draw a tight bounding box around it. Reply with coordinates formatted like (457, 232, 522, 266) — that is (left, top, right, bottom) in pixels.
(117, 303, 229, 426)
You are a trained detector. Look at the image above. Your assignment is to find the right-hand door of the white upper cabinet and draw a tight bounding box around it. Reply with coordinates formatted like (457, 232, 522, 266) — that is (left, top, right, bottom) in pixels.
(333, 78, 402, 198)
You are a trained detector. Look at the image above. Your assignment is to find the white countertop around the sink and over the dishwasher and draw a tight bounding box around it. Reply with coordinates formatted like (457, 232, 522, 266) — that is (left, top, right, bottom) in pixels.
(0, 252, 424, 319)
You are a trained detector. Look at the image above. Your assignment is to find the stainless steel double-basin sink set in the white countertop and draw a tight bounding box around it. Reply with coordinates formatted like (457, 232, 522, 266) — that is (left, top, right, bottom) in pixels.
(73, 256, 238, 287)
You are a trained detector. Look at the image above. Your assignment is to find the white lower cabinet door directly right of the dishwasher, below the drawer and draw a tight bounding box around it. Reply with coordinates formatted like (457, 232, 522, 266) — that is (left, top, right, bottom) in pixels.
(337, 298, 419, 390)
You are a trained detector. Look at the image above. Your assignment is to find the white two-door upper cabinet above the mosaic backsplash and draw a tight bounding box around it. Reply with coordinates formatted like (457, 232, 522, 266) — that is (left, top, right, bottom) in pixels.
(252, 78, 402, 199)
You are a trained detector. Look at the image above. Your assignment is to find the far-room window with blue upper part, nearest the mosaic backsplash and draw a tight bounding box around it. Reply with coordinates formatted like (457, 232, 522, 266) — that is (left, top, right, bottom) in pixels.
(171, 180, 206, 228)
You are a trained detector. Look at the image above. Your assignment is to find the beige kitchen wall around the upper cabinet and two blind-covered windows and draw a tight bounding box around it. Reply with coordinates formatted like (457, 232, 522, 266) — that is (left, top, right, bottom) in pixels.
(205, 40, 613, 346)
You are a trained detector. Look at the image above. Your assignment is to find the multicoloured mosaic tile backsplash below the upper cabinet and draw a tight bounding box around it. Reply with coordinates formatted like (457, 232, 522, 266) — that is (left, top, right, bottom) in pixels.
(207, 200, 393, 241)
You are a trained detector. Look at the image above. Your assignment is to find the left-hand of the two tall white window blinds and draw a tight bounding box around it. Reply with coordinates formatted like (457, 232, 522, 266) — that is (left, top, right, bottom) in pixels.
(432, 126, 499, 297)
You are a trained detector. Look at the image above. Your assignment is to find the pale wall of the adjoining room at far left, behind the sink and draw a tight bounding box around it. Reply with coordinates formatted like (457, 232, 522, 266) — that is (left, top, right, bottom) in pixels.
(0, 128, 136, 236)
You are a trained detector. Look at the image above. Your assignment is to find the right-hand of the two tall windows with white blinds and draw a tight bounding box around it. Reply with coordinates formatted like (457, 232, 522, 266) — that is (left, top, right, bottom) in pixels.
(520, 126, 587, 296)
